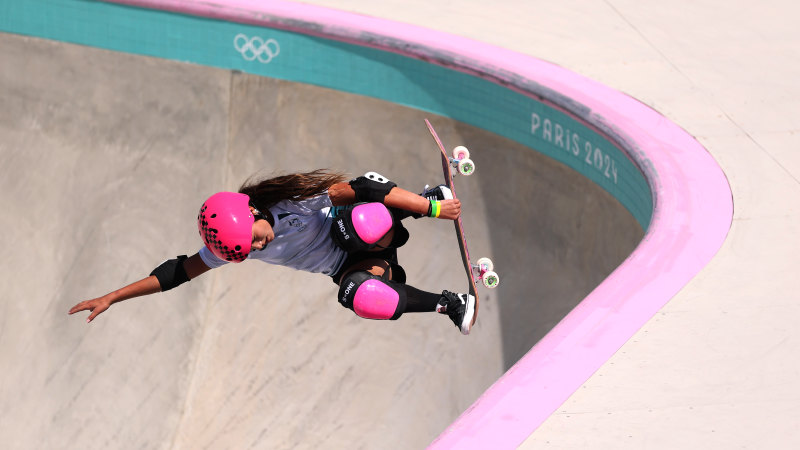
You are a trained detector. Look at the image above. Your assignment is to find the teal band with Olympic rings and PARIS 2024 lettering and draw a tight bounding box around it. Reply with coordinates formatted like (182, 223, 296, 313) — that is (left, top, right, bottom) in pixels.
(0, 0, 653, 229)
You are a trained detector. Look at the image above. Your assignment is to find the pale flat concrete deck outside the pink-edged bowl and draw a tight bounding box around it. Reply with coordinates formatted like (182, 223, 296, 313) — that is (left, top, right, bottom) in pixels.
(296, 0, 800, 449)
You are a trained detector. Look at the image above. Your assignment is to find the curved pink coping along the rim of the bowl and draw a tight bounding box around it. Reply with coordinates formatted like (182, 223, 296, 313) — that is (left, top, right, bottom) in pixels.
(103, 0, 733, 449)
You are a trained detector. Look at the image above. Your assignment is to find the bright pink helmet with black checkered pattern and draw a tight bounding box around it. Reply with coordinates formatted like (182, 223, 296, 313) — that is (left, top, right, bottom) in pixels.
(197, 192, 255, 262)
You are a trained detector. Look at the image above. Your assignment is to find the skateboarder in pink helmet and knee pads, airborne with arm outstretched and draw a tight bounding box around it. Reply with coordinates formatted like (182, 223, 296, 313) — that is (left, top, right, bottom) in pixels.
(69, 170, 475, 334)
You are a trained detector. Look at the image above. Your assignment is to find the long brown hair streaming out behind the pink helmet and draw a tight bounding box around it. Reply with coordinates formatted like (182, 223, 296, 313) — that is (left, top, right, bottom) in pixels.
(239, 169, 348, 211)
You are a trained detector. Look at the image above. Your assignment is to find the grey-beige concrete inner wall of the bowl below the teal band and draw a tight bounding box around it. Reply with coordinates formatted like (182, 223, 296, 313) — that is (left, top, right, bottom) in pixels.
(0, 35, 642, 449)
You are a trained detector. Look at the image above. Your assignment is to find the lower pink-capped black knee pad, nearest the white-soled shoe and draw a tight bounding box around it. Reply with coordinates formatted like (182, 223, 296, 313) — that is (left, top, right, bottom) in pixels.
(339, 270, 408, 320)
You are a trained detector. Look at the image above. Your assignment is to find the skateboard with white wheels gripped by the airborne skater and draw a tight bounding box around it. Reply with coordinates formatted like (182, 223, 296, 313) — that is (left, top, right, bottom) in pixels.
(425, 119, 500, 325)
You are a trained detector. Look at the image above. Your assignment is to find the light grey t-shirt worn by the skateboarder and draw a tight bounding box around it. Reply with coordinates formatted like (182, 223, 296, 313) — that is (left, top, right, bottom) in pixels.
(200, 193, 347, 275)
